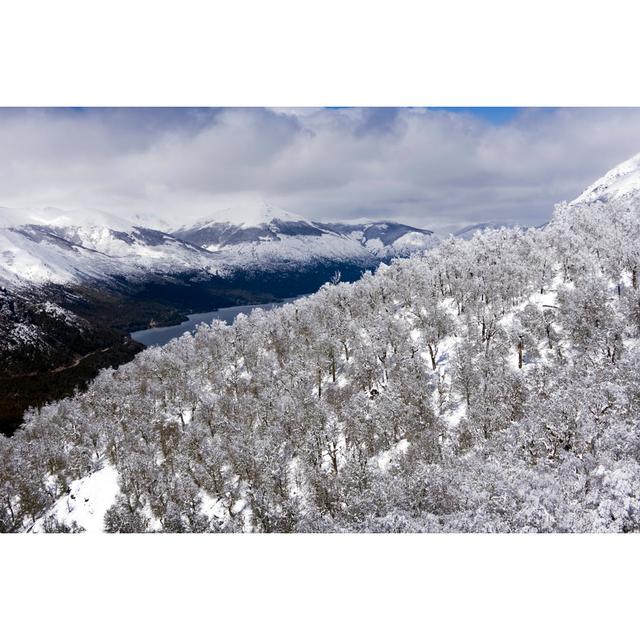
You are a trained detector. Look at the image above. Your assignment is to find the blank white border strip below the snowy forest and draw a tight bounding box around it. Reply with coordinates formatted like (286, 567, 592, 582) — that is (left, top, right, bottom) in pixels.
(0, 534, 640, 640)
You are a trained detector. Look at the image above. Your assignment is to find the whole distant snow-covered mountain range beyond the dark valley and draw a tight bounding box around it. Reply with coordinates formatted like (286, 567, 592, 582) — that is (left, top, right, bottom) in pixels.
(0, 202, 435, 287)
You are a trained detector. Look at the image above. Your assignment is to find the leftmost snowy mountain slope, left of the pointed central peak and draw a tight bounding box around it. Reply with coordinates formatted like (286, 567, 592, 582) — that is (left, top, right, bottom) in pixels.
(0, 208, 228, 286)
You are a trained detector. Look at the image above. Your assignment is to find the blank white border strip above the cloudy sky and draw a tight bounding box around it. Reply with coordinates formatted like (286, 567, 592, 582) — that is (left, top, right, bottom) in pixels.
(0, 0, 640, 106)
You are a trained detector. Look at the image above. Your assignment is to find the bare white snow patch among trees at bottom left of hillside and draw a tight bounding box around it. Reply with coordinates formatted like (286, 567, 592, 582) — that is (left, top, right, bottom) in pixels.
(30, 464, 120, 533)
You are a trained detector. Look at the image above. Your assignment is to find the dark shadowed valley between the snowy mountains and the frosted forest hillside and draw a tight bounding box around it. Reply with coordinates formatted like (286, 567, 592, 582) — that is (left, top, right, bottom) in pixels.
(0, 264, 370, 435)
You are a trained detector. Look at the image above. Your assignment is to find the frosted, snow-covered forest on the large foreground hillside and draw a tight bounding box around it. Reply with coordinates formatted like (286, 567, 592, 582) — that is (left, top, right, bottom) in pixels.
(0, 198, 640, 532)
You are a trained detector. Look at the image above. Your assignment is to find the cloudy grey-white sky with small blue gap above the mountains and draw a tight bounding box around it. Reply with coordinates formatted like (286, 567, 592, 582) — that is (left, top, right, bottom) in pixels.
(0, 108, 640, 232)
